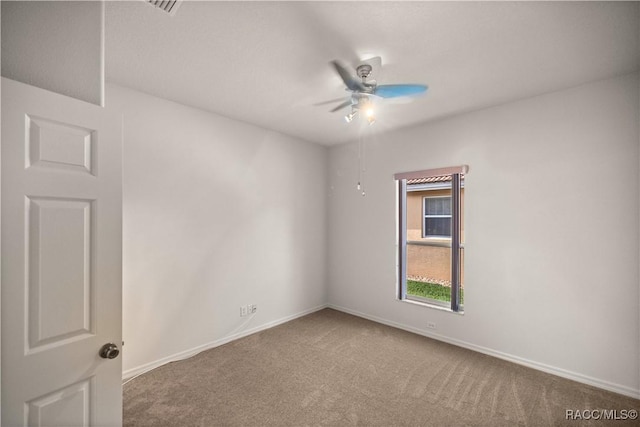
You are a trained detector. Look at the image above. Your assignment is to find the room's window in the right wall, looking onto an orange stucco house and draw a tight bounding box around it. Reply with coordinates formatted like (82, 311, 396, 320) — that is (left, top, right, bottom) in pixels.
(395, 166, 468, 312)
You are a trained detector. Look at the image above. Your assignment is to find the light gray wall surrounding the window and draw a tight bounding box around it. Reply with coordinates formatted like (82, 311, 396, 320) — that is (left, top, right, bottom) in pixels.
(328, 74, 640, 397)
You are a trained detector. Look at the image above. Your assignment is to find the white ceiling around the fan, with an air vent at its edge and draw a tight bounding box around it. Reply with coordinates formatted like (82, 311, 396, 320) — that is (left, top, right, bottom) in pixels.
(106, 1, 640, 145)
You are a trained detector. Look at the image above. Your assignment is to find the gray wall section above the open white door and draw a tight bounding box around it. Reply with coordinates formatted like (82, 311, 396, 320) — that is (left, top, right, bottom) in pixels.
(1, 1, 104, 105)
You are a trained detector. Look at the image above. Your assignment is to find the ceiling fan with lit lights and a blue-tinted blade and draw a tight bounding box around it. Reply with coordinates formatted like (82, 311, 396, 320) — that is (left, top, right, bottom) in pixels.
(323, 57, 428, 124)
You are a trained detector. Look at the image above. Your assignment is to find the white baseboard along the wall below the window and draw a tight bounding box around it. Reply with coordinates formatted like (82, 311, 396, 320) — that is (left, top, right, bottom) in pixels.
(328, 304, 640, 399)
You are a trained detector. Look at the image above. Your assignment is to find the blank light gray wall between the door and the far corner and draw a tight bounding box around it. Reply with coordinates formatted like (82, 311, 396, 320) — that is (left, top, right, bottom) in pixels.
(107, 85, 327, 377)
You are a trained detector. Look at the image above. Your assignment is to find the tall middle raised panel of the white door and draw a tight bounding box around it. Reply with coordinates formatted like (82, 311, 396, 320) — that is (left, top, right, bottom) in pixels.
(26, 197, 95, 354)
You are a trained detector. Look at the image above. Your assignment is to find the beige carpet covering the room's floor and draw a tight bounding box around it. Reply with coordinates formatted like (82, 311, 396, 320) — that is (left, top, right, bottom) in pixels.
(124, 309, 640, 426)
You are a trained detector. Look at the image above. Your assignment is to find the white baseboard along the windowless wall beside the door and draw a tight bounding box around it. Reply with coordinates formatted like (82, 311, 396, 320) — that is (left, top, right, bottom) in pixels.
(122, 304, 328, 381)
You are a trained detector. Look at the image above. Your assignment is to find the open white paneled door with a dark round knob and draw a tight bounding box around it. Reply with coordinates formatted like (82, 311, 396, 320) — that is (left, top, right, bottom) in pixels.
(1, 78, 122, 427)
